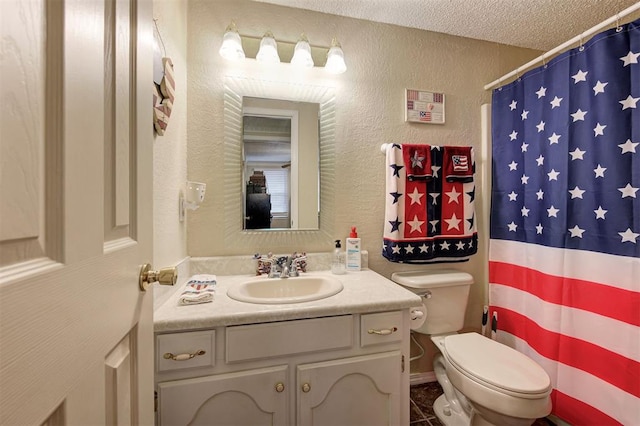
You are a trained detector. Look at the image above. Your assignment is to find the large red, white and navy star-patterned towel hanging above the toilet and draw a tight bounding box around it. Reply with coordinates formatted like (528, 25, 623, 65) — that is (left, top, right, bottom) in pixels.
(382, 144, 478, 263)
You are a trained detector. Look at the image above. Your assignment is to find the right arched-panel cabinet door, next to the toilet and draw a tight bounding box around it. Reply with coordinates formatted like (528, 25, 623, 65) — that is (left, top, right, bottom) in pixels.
(296, 351, 403, 426)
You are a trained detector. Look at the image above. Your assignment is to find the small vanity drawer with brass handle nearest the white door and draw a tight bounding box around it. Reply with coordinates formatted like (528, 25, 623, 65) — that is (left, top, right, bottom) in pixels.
(156, 330, 216, 372)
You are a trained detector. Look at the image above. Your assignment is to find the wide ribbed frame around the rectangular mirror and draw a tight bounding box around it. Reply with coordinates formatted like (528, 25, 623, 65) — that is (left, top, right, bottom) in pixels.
(224, 76, 336, 251)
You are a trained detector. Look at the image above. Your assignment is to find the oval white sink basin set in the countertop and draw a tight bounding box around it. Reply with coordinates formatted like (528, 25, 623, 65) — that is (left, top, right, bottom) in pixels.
(227, 276, 343, 304)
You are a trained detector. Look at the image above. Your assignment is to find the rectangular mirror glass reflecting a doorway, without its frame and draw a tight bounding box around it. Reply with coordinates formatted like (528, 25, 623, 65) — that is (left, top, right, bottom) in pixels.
(242, 96, 320, 230)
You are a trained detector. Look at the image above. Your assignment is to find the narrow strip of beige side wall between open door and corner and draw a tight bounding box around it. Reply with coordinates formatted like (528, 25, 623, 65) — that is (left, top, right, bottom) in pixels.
(153, 0, 187, 268)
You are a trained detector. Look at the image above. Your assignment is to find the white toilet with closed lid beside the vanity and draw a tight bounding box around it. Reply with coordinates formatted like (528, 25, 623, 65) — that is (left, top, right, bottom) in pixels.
(391, 269, 551, 426)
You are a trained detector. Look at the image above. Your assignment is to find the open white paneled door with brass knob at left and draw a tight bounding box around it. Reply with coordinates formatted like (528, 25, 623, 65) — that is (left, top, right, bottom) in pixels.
(0, 0, 153, 425)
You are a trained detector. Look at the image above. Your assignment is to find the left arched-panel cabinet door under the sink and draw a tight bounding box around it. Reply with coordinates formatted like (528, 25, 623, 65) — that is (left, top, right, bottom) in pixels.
(158, 366, 289, 426)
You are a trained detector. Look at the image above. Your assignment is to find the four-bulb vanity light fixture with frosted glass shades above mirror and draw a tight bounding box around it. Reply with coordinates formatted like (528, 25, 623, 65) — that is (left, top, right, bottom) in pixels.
(219, 22, 347, 74)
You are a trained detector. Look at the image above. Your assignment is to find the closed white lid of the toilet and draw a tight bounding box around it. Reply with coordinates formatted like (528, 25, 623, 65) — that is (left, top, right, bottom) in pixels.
(444, 333, 551, 394)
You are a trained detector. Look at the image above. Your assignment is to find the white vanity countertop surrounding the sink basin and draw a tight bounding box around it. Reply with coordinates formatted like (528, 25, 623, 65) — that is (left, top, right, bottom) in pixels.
(153, 269, 422, 333)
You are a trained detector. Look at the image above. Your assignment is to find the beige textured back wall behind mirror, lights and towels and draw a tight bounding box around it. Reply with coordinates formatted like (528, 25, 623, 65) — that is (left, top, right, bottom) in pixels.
(188, 0, 540, 371)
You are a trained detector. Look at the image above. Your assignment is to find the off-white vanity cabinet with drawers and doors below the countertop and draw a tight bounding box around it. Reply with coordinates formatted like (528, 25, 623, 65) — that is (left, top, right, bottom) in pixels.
(156, 310, 409, 426)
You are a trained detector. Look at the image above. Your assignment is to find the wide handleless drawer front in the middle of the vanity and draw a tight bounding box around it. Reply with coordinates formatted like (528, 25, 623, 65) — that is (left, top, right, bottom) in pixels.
(226, 315, 353, 362)
